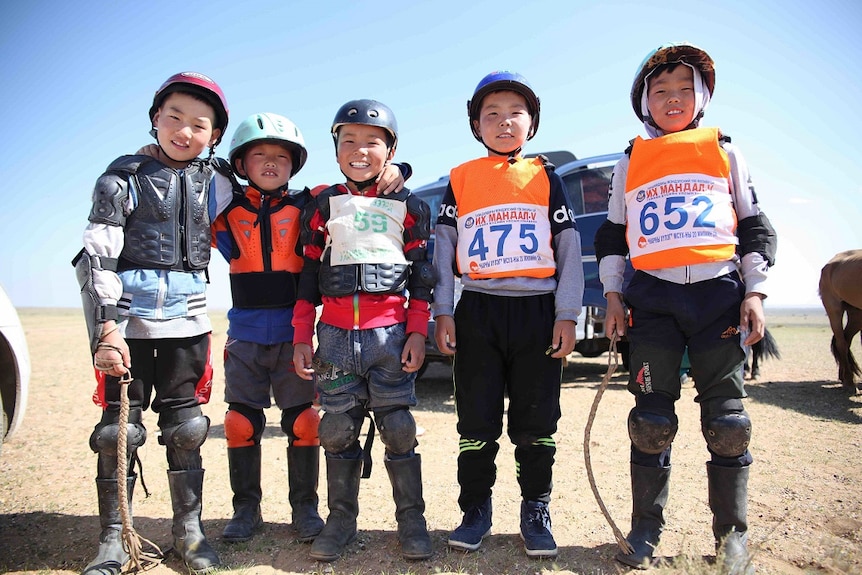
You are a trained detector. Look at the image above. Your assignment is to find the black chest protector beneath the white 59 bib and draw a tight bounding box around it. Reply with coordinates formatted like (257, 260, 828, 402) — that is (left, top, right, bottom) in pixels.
(317, 186, 410, 297)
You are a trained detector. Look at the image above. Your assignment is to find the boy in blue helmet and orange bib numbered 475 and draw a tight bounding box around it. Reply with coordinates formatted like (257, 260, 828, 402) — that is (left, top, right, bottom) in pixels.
(432, 71, 584, 557)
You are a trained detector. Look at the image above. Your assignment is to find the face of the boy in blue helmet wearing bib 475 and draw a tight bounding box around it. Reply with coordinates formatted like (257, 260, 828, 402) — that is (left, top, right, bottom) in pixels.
(473, 91, 532, 156)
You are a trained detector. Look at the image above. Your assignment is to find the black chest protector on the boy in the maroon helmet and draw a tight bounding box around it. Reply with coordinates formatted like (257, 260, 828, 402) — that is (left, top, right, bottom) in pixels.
(90, 156, 213, 271)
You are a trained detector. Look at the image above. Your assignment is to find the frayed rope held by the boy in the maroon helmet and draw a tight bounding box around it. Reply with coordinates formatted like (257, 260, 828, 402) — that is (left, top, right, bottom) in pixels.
(117, 371, 164, 571)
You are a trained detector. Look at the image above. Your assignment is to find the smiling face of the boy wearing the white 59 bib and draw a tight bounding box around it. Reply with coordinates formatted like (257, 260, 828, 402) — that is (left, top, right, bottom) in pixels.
(335, 124, 395, 189)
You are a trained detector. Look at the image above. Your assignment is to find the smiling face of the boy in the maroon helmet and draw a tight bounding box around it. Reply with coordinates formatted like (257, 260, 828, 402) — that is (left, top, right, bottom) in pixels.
(153, 92, 221, 168)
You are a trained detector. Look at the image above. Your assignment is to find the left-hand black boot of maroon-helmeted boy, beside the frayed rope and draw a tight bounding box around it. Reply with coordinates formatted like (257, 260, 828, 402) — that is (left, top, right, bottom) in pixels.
(81, 476, 136, 575)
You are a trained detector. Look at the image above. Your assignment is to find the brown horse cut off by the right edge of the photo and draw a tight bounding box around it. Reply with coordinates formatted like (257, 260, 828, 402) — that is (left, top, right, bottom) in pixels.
(820, 250, 862, 392)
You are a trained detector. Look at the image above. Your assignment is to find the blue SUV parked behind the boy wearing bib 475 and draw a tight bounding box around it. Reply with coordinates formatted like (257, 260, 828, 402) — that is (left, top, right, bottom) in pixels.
(413, 151, 634, 376)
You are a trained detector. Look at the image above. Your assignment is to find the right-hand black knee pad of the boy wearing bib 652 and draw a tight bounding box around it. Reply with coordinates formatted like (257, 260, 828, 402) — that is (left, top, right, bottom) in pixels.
(700, 397, 751, 458)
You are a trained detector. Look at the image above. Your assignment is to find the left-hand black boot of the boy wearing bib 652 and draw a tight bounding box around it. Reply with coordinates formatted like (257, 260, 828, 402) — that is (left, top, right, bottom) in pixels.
(615, 463, 670, 569)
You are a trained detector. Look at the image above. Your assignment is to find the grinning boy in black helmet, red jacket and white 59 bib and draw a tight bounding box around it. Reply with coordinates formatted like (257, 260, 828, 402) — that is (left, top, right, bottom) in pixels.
(293, 100, 434, 561)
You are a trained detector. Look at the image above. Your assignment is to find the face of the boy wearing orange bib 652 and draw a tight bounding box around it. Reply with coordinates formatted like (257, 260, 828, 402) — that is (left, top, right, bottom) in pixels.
(647, 64, 695, 134)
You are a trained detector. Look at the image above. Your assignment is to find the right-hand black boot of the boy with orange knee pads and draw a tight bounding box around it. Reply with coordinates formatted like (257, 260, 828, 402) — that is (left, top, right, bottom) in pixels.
(287, 445, 324, 543)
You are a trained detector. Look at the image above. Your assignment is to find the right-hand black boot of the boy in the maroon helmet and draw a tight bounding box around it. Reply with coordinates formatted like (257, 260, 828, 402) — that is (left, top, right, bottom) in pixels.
(168, 469, 219, 573)
